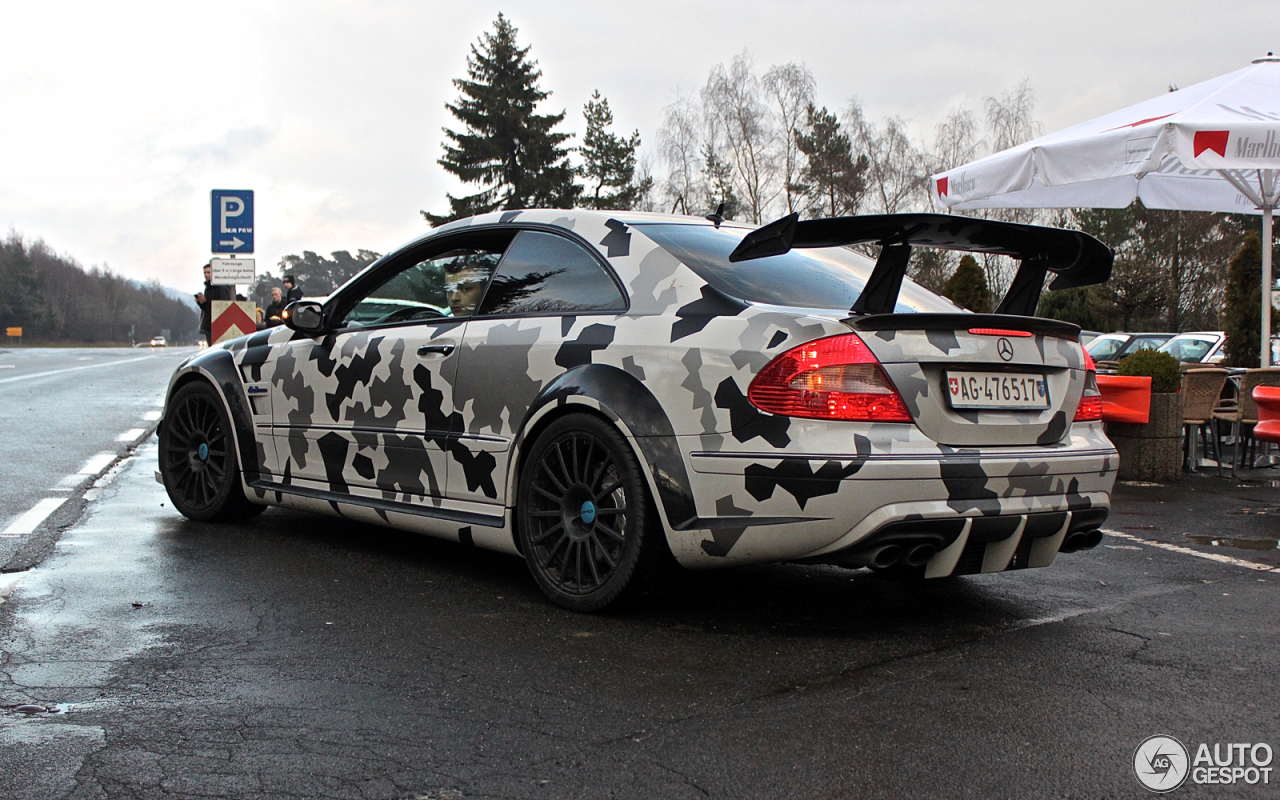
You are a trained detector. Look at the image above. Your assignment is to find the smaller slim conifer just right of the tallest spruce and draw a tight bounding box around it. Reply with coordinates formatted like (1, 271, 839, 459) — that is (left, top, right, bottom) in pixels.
(577, 90, 653, 210)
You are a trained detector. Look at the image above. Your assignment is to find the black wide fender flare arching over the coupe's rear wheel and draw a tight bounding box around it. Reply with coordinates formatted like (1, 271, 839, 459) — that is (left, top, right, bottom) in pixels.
(507, 364, 698, 531)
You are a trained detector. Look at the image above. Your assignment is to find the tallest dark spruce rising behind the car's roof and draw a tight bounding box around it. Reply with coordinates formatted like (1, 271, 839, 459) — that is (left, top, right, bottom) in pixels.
(422, 14, 581, 225)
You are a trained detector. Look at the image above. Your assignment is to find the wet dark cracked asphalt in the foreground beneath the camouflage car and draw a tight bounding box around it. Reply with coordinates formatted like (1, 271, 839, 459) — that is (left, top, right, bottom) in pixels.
(0, 424, 1280, 800)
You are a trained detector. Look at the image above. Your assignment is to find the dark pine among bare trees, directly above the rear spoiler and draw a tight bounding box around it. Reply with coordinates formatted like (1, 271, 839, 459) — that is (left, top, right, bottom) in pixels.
(792, 104, 868, 216)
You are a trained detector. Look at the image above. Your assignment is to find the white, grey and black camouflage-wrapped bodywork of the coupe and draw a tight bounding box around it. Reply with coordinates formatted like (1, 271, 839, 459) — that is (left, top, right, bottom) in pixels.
(170, 210, 1119, 576)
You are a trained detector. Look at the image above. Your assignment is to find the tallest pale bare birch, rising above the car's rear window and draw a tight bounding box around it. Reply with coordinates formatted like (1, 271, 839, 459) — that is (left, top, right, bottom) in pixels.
(703, 51, 778, 223)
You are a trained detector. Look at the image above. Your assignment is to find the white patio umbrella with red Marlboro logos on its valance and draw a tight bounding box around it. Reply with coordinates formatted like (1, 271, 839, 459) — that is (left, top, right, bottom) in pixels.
(932, 54, 1280, 366)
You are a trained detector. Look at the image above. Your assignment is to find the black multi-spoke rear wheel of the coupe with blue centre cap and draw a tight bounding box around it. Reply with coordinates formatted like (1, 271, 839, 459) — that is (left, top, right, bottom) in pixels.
(517, 413, 664, 611)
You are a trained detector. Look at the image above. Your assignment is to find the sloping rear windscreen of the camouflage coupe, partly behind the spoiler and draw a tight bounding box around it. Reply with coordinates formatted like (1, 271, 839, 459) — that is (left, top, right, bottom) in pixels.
(636, 224, 961, 314)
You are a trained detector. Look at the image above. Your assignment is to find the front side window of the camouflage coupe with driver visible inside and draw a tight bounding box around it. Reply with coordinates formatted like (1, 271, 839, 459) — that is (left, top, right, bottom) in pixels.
(340, 234, 511, 328)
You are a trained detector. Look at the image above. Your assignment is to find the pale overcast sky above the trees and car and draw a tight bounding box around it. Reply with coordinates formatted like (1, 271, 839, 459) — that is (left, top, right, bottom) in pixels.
(0, 0, 1280, 291)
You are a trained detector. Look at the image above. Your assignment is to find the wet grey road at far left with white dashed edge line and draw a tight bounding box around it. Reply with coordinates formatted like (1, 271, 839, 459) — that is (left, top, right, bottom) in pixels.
(0, 347, 195, 568)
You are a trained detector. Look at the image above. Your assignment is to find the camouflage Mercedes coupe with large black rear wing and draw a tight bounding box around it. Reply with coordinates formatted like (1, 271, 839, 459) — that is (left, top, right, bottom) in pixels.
(160, 210, 1117, 611)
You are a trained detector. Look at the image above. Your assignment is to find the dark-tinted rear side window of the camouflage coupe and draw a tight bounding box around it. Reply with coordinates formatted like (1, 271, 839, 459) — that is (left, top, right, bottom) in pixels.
(480, 230, 626, 315)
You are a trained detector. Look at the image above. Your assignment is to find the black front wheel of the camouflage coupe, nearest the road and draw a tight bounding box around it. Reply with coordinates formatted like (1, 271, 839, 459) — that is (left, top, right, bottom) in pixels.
(160, 380, 264, 522)
